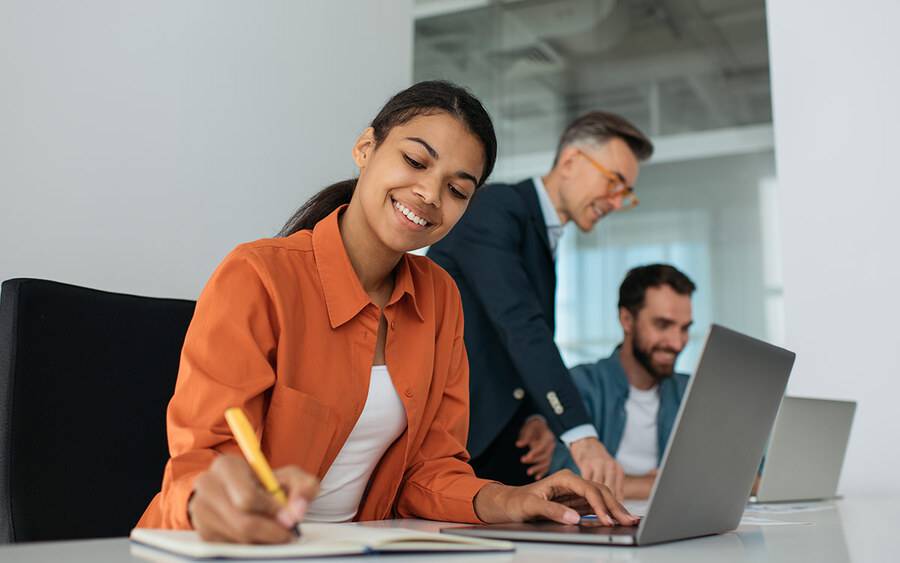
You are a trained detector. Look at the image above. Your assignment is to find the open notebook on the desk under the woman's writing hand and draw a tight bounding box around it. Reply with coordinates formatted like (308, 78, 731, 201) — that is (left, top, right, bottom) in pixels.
(131, 523, 514, 559)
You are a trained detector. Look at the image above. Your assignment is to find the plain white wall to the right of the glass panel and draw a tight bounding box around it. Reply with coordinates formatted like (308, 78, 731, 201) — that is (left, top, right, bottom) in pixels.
(768, 0, 900, 494)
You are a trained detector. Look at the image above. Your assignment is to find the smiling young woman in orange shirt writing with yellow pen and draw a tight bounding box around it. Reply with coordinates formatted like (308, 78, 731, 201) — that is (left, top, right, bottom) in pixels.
(138, 82, 636, 543)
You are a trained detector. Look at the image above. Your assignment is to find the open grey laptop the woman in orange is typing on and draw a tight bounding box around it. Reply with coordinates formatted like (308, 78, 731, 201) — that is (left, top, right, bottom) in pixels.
(441, 325, 794, 545)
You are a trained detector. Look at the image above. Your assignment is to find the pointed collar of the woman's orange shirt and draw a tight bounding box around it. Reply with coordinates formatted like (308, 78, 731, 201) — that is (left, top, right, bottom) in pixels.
(312, 204, 425, 328)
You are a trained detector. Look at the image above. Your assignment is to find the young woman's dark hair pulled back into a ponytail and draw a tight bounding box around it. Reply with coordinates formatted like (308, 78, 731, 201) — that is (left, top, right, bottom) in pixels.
(278, 80, 497, 237)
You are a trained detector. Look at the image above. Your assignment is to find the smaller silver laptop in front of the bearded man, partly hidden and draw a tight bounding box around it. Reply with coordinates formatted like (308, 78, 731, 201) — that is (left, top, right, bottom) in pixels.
(750, 397, 856, 502)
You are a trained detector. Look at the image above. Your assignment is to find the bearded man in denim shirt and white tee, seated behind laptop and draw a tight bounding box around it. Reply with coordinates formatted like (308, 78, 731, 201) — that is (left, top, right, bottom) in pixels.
(550, 264, 696, 499)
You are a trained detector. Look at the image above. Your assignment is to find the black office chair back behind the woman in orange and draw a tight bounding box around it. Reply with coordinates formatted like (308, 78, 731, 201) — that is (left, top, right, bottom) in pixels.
(0, 279, 194, 544)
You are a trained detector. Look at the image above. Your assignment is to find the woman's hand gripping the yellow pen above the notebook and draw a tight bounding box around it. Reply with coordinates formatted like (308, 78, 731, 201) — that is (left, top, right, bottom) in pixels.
(188, 455, 319, 543)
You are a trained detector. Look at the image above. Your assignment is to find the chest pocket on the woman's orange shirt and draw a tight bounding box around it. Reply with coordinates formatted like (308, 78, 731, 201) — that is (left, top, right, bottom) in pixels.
(262, 384, 337, 476)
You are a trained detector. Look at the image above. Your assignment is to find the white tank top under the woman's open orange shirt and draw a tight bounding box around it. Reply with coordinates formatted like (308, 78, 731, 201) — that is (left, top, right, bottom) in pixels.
(304, 366, 406, 522)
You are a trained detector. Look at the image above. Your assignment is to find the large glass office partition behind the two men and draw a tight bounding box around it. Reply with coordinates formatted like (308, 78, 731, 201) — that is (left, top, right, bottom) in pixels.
(414, 0, 783, 371)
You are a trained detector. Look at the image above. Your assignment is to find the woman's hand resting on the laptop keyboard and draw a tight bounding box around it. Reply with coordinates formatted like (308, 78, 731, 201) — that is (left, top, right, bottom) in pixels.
(474, 469, 639, 526)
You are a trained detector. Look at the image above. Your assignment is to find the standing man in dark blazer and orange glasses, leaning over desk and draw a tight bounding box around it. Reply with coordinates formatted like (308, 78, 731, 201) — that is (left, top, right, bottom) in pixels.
(428, 112, 653, 496)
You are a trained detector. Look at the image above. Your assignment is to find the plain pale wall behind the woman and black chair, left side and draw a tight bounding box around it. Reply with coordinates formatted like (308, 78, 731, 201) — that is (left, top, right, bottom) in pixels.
(0, 0, 412, 298)
